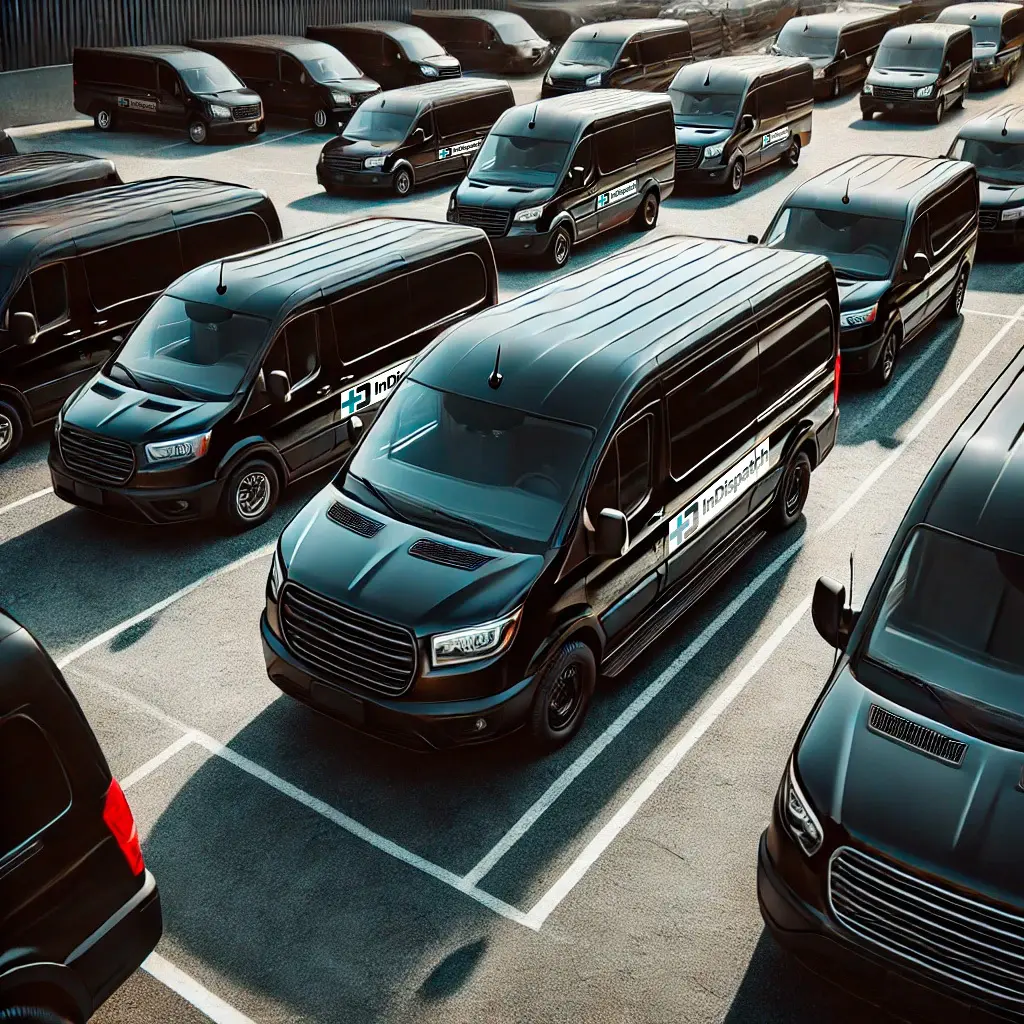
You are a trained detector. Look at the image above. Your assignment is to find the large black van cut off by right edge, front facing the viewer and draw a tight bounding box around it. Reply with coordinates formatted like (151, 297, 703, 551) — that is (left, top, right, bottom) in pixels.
(758, 339, 1024, 1024)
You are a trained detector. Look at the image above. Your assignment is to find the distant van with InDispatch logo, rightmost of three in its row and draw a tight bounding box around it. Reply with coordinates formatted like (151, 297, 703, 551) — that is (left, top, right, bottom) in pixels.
(669, 54, 814, 193)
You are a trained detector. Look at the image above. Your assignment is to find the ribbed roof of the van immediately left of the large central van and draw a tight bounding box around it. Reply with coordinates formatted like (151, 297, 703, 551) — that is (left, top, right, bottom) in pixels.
(172, 217, 485, 321)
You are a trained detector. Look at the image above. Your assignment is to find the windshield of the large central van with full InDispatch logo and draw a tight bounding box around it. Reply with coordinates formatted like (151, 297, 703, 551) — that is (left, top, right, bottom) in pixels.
(338, 378, 594, 552)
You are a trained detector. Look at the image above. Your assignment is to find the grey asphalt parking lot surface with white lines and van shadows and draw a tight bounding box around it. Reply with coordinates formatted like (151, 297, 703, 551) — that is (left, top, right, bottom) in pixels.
(8, 72, 1024, 1024)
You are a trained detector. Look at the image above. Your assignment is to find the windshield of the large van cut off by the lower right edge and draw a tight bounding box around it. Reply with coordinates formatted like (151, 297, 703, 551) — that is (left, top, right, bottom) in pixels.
(865, 526, 1024, 715)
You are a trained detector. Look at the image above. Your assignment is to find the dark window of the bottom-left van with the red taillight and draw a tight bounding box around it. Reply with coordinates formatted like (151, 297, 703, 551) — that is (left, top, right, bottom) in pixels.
(0, 715, 71, 861)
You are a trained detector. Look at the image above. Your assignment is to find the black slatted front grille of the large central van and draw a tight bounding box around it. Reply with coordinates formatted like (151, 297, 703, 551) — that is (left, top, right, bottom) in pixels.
(281, 583, 416, 696)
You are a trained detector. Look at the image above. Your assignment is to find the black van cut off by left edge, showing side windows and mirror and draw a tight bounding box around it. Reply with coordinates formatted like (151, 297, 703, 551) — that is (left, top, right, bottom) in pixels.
(0, 178, 281, 462)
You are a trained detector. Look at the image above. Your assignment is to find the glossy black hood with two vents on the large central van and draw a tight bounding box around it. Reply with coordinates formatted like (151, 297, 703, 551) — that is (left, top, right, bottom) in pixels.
(281, 484, 544, 636)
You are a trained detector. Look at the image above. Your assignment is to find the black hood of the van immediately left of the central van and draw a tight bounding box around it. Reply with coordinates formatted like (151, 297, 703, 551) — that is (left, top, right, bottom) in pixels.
(63, 374, 230, 444)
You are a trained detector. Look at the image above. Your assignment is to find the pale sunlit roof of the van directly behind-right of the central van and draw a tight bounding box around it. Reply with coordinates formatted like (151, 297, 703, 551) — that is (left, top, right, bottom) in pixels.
(785, 154, 975, 220)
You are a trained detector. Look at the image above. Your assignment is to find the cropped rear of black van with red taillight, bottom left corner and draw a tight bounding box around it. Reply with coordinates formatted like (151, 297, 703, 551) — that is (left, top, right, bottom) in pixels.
(0, 611, 163, 1024)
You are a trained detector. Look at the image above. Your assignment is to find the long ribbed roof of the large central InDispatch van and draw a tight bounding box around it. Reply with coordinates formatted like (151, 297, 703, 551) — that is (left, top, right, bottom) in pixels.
(410, 234, 835, 428)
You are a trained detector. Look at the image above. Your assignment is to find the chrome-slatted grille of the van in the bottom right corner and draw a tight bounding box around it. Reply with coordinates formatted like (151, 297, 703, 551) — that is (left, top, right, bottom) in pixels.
(828, 847, 1024, 1009)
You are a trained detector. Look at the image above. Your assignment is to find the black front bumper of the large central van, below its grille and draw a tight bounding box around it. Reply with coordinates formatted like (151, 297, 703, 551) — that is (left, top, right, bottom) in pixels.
(260, 612, 537, 750)
